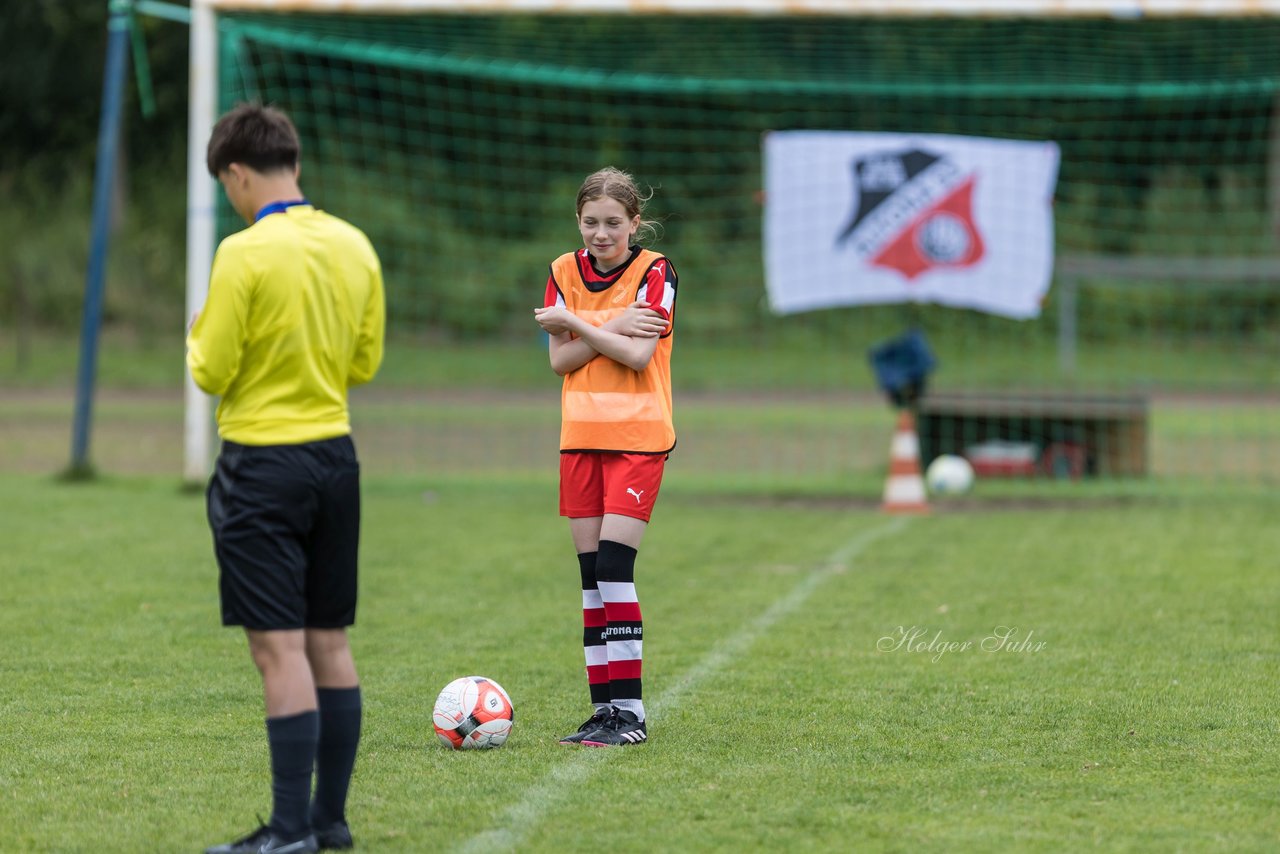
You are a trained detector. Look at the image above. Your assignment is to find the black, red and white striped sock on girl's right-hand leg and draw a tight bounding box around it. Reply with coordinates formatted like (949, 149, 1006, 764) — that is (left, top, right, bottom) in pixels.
(595, 540, 645, 721)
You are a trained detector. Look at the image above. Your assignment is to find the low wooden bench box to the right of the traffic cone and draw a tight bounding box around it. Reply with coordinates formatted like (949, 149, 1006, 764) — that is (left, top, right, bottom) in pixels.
(916, 392, 1148, 478)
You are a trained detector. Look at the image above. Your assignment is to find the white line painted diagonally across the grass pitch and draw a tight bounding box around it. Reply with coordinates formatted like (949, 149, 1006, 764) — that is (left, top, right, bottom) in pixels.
(457, 516, 908, 854)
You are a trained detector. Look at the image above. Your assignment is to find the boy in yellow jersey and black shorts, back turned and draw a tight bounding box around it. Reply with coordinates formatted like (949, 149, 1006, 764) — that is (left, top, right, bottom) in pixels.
(187, 104, 385, 854)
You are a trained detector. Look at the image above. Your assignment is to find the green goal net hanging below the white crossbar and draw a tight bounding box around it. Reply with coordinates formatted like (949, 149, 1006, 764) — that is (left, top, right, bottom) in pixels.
(209, 14, 1280, 488)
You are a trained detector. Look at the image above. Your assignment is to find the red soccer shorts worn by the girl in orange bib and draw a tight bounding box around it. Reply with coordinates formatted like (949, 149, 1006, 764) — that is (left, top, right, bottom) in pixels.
(561, 452, 667, 521)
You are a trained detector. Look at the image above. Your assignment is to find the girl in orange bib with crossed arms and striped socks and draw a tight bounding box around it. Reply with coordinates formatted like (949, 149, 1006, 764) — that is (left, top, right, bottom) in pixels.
(534, 168, 677, 746)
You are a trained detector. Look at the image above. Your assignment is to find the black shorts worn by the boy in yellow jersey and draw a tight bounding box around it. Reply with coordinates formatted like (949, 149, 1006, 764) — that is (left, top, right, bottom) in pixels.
(207, 437, 360, 630)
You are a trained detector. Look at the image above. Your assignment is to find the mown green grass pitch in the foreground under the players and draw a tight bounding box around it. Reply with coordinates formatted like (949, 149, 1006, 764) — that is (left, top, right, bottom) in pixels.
(0, 474, 1280, 851)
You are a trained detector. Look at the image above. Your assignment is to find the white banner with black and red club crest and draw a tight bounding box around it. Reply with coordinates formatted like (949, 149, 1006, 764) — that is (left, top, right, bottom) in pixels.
(764, 131, 1059, 319)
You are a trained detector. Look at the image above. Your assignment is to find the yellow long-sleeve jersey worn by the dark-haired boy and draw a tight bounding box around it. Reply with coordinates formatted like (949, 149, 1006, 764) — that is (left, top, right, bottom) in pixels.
(187, 204, 387, 444)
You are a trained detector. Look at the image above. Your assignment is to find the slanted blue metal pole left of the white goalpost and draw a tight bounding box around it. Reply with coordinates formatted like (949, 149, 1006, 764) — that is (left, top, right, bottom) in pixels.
(68, 0, 133, 478)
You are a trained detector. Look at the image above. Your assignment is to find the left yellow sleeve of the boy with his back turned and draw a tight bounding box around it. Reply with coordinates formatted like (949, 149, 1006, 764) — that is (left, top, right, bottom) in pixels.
(187, 248, 248, 394)
